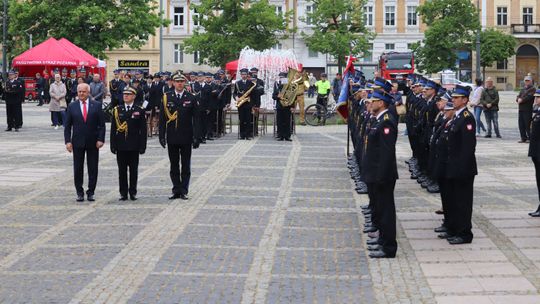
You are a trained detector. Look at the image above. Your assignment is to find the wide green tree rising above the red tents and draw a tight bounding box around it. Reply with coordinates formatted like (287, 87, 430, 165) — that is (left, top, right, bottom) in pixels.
(9, 0, 168, 58)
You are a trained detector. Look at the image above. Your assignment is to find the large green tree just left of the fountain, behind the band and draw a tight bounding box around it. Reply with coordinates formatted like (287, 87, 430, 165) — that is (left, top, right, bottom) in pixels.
(183, 0, 290, 67)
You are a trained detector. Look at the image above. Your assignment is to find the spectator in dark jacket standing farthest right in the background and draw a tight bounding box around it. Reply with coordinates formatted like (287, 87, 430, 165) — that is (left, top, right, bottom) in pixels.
(516, 74, 535, 143)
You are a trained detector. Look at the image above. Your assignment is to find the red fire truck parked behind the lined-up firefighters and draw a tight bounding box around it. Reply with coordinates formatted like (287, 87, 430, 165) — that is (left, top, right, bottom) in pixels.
(379, 52, 414, 80)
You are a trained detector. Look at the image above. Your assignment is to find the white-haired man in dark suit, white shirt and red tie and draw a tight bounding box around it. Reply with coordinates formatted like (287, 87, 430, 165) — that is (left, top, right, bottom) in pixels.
(64, 83, 105, 202)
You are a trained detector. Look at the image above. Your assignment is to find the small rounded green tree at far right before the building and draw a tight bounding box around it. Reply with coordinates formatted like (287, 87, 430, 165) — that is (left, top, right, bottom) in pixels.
(480, 28, 517, 77)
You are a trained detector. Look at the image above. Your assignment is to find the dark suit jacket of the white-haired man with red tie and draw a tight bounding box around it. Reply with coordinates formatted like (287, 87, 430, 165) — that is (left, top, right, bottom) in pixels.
(64, 100, 105, 148)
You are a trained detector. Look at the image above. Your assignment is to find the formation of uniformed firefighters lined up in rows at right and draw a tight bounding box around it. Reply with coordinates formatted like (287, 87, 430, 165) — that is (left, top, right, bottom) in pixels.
(348, 74, 477, 258)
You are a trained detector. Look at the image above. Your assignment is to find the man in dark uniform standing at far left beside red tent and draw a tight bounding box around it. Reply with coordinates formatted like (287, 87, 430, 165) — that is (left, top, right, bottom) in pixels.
(4, 71, 24, 132)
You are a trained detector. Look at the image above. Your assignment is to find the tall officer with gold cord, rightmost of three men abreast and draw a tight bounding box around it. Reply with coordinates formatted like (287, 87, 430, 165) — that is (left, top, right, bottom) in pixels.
(159, 72, 204, 200)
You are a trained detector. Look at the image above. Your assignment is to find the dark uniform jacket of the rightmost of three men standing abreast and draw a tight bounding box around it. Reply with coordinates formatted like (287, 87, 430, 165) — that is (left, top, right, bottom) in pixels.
(159, 90, 200, 145)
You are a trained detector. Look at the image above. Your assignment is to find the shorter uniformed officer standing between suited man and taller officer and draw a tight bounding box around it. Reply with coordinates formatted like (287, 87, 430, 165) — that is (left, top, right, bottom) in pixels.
(111, 86, 146, 201)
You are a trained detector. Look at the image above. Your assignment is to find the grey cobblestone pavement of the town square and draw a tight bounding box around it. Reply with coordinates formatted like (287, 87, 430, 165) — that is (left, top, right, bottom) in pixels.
(0, 93, 540, 304)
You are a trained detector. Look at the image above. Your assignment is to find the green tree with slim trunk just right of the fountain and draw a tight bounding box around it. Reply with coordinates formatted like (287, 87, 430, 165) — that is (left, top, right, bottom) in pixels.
(302, 0, 375, 73)
